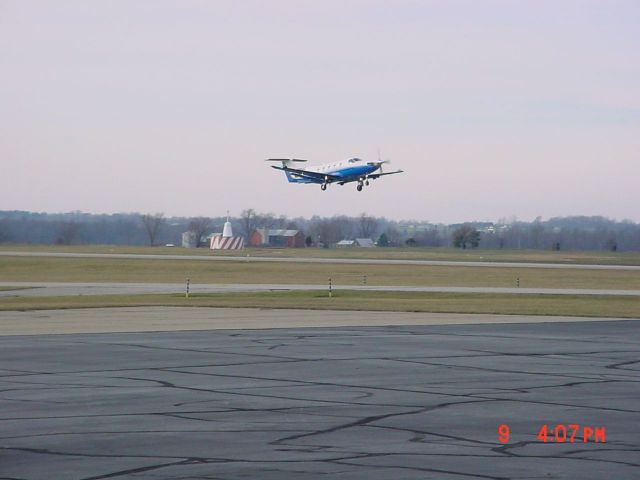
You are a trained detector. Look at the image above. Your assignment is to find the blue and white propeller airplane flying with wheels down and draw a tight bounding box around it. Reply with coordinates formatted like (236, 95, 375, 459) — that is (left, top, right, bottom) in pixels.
(266, 157, 402, 192)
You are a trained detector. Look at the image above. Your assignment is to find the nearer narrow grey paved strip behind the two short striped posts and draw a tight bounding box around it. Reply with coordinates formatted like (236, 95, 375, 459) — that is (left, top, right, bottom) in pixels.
(0, 282, 640, 298)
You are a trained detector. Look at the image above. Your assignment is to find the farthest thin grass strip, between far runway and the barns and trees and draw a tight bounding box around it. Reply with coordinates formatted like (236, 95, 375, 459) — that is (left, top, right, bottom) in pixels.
(0, 244, 640, 265)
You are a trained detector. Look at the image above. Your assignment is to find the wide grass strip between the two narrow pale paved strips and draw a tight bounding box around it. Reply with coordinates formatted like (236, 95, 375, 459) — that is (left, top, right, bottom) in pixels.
(0, 257, 640, 290)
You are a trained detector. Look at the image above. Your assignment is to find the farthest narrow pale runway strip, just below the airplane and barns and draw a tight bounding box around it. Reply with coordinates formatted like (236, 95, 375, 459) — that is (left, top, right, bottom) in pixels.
(0, 251, 640, 271)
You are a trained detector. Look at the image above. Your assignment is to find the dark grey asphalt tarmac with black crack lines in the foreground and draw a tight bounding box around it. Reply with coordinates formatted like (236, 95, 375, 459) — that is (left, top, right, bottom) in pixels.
(0, 312, 640, 480)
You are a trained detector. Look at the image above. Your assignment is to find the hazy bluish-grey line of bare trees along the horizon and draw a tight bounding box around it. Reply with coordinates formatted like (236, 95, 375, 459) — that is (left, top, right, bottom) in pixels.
(0, 209, 640, 251)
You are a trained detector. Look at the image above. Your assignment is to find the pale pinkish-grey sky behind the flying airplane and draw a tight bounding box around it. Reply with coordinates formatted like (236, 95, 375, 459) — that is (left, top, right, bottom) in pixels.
(0, 0, 640, 223)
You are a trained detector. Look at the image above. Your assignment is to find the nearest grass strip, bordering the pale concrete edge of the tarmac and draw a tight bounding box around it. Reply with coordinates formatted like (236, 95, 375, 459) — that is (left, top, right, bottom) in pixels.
(0, 291, 640, 318)
